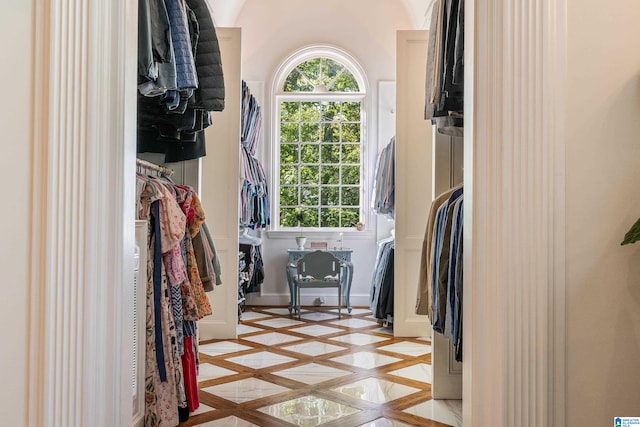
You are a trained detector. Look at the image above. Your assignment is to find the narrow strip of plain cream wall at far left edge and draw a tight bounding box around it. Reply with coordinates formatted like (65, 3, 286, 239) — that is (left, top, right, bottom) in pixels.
(0, 1, 33, 426)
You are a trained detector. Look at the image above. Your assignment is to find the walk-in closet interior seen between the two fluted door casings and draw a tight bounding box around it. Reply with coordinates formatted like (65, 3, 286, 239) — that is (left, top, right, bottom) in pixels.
(134, 0, 464, 426)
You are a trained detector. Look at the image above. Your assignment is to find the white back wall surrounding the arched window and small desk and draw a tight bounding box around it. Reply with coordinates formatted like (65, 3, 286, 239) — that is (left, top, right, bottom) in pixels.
(234, 0, 414, 305)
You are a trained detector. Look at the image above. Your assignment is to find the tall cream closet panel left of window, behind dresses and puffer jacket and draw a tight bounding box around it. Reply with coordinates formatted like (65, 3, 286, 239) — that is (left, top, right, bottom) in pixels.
(138, 28, 242, 340)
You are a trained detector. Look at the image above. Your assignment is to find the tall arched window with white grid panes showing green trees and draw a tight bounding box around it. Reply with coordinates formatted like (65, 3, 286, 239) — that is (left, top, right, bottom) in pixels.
(272, 47, 366, 230)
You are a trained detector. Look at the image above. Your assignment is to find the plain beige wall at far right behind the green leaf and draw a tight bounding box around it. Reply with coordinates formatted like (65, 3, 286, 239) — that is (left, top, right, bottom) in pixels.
(566, 0, 640, 426)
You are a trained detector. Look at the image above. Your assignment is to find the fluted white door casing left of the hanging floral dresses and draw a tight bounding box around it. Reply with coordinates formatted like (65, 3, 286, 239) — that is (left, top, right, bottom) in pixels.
(29, 0, 137, 427)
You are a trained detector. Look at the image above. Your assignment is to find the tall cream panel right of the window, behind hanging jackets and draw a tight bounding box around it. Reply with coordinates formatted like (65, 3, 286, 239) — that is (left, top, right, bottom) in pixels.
(393, 30, 433, 337)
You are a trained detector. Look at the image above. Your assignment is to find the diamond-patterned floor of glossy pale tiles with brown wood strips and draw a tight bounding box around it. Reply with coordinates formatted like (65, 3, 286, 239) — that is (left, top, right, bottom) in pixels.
(180, 307, 457, 427)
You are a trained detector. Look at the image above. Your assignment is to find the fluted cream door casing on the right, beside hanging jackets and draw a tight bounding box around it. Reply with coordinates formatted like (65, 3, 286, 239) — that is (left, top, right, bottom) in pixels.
(463, 0, 566, 427)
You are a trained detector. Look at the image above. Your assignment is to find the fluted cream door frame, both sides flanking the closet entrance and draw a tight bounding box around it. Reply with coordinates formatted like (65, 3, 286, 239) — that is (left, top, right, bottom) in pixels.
(28, 0, 566, 427)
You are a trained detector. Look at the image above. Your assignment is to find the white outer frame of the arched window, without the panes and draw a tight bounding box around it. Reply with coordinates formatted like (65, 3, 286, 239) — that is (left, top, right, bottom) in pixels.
(269, 45, 371, 237)
